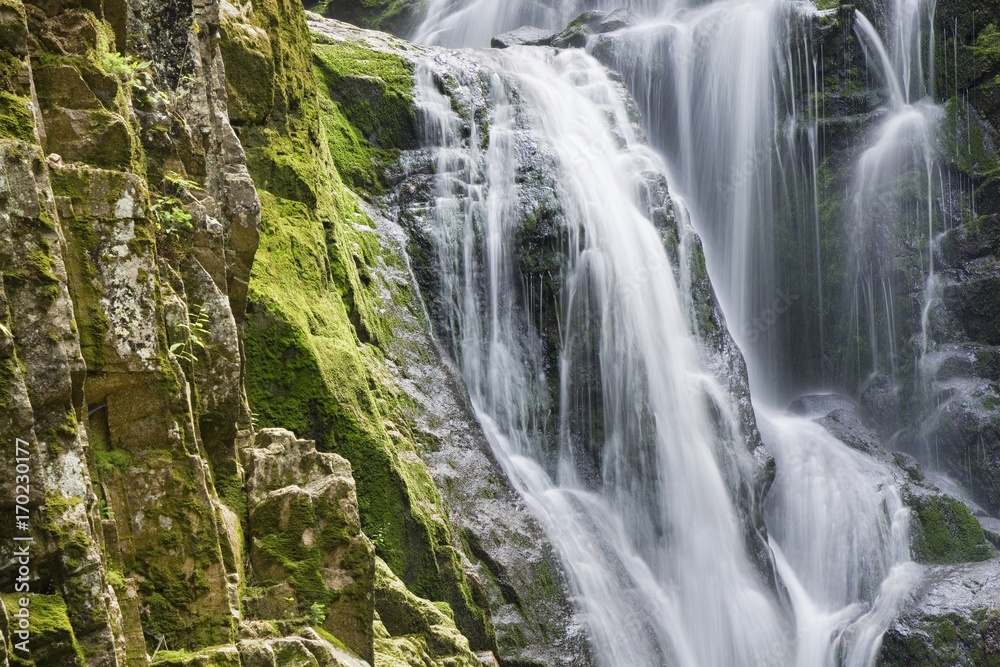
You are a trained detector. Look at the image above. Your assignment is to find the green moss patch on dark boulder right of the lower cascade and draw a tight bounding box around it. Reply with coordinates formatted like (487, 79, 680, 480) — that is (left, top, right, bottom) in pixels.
(907, 496, 994, 563)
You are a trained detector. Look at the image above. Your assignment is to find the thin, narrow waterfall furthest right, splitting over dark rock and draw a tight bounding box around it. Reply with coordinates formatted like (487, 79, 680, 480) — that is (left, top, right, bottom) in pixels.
(849, 5, 943, 388)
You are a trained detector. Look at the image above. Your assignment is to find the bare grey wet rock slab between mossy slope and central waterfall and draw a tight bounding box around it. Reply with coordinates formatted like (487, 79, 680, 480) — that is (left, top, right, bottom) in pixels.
(360, 196, 590, 667)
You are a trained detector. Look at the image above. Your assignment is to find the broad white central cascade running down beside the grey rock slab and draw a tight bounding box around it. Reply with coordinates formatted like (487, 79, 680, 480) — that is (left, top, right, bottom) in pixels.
(419, 51, 785, 666)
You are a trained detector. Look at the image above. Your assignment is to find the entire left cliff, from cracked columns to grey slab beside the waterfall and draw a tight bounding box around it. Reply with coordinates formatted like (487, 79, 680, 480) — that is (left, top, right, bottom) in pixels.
(0, 0, 586, 667)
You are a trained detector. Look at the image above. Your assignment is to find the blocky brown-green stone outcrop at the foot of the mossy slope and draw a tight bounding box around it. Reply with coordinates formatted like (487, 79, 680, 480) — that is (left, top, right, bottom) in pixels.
(241, 429, 375, 663)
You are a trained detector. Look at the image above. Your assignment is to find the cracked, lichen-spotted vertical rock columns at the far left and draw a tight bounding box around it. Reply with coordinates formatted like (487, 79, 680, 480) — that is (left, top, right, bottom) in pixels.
(0, 2, 259, 665)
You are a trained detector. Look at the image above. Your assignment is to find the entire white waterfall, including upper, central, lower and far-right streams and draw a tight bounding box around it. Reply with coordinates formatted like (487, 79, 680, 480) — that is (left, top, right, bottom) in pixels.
(406, 0, 938, 667)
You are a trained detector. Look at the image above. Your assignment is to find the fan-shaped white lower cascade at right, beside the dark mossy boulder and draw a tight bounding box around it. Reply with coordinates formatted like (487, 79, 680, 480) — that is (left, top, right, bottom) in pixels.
(758, 411, 921, 667)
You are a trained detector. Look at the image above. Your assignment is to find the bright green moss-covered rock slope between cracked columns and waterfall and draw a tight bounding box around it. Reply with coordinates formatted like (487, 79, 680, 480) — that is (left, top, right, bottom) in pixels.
(240, 0, 495, 650)
